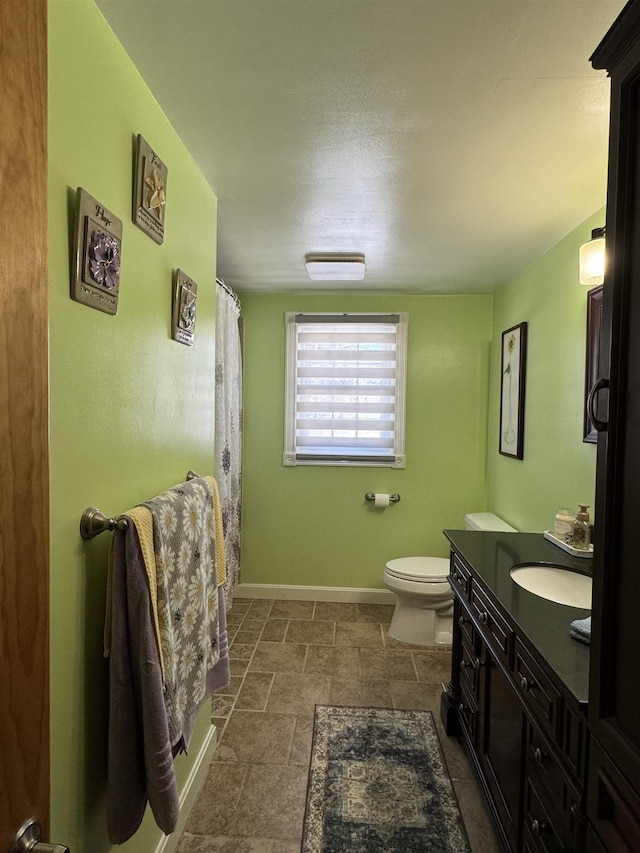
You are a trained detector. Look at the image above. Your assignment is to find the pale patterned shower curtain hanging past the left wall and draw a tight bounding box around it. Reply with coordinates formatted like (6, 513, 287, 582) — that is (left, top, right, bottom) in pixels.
(214, 280, 242, 609)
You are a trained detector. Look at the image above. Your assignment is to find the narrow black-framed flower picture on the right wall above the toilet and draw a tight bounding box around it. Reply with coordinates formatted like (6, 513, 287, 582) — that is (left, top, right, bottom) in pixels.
(499, 323, 527, 459)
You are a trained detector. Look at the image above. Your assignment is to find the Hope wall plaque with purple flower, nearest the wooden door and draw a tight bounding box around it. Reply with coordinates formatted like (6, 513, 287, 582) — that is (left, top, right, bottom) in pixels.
(71, 187, 122, 314)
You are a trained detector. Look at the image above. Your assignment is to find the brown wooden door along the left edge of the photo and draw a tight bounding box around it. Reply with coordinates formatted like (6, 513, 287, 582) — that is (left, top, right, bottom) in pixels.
(0, 0, 50, 853)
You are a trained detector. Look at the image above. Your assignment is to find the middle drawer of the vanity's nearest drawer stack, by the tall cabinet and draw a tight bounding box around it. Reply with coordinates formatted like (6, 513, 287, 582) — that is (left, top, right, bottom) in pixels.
(525, 719, 586, 850)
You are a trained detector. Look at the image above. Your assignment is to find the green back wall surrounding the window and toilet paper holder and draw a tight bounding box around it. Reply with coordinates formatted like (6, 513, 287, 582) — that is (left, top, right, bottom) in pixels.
(242, 294, 492, 588)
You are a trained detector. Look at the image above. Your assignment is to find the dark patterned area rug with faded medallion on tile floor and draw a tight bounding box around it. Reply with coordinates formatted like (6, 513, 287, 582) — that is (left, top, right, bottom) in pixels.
(302, 705, 470, 853)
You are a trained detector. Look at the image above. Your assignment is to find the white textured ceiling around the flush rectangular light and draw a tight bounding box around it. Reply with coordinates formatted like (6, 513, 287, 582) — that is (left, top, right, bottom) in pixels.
(96, 0, 624, 293)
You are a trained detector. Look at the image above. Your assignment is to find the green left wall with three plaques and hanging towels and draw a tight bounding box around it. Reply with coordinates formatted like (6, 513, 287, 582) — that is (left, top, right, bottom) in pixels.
(49, 0, 216, 853)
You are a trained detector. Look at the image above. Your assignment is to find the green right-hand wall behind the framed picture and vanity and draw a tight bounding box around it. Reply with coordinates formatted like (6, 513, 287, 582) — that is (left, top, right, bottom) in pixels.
(487, 209, 605, 531)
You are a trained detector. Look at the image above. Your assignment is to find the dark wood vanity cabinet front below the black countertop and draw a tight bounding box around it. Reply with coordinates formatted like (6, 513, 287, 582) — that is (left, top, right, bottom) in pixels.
(443, 549, 588, 853)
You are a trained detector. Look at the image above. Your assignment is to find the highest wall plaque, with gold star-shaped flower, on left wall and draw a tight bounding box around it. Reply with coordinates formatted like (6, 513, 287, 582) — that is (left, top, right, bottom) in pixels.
(132, 134, 168, 243)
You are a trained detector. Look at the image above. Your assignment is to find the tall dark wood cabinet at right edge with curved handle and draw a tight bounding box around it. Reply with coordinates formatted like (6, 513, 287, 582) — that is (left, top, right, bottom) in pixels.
(586, 0, 640, 853)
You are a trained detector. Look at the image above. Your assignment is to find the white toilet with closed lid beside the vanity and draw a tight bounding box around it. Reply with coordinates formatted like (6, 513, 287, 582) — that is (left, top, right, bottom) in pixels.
(384, 512, 516, 646)
